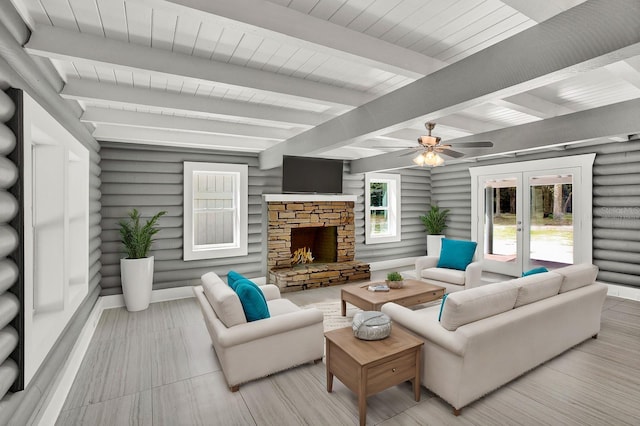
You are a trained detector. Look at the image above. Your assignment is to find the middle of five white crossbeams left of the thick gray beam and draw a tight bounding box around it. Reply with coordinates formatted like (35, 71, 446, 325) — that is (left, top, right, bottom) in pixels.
(60, 79, 332, 127)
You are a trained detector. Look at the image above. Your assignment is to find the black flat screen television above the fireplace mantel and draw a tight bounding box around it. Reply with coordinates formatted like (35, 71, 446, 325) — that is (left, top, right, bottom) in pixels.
(282, 155, 343, 194)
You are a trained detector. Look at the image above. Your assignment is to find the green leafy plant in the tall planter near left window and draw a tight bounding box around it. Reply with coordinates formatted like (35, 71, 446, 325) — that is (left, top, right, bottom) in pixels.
(119, 209, 167, 259)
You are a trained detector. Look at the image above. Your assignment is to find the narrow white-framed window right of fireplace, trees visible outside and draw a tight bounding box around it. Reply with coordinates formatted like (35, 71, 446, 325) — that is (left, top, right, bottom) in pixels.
(365, 173, 400, 244)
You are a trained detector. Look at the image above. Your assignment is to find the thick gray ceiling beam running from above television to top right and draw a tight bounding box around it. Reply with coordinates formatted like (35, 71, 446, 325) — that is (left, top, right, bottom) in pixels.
(260, 0, 640, 169)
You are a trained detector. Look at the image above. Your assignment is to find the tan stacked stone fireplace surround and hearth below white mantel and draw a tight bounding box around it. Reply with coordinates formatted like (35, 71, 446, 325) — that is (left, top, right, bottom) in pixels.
(267, 201, 370, 291)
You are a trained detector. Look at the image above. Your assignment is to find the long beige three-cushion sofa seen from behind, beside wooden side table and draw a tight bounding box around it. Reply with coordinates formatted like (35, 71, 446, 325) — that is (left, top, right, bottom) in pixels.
(382, 264, 607, 415)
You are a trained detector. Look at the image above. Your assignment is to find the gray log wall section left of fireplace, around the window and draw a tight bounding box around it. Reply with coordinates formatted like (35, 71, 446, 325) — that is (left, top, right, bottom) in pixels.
(100, 142, 281, 295)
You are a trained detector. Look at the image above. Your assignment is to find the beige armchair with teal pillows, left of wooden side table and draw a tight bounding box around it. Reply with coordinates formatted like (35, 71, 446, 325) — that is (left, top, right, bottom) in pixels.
(193, 272, 324, 392)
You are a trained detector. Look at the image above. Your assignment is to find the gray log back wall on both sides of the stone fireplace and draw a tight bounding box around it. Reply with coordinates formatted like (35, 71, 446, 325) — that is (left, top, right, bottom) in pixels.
(100, 142, 430, 295)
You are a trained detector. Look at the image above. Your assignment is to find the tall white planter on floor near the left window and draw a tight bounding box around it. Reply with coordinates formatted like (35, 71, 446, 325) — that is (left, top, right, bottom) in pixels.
(120, 256, 153, 312)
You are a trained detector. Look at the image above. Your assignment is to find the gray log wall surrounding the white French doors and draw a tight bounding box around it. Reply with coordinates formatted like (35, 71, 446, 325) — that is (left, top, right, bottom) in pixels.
(431, 140, 640, 287)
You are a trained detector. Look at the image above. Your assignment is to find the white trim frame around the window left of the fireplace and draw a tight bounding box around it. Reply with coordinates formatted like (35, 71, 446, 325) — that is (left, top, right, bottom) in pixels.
(183, 161, 249, 261)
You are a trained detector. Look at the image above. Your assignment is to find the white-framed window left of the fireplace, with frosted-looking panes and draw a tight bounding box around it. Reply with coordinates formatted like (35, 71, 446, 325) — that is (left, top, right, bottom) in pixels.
(183, 162, 248, 260)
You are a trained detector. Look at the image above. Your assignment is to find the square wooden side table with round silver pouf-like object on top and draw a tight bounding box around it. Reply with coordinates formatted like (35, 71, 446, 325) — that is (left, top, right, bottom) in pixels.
(324, 326, 424, 425)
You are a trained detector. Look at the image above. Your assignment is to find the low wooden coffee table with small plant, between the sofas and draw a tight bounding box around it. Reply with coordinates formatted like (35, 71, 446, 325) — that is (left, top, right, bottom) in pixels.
(340, 280, 445, 316)
